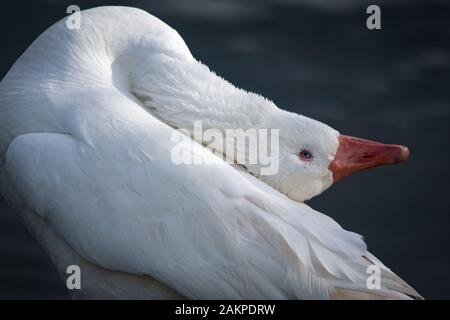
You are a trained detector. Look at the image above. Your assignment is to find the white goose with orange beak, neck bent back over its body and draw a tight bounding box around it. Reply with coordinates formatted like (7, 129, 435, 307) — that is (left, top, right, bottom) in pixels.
(0, 7, 420, 299)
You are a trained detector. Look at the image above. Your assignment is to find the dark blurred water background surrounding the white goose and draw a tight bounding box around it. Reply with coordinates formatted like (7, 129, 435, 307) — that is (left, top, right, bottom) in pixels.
(0, 0, 450, 299)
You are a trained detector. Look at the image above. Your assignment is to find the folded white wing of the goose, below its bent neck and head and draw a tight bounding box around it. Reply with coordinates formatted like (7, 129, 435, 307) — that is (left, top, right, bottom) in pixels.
(6, 92, 414, 299)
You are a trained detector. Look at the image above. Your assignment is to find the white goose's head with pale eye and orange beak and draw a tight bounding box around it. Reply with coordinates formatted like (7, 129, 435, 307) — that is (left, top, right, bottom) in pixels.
(255, 110, 409, 201)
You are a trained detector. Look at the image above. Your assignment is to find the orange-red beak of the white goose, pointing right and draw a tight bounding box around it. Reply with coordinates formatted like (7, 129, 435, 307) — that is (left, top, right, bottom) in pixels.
(328, 135, 409, 182)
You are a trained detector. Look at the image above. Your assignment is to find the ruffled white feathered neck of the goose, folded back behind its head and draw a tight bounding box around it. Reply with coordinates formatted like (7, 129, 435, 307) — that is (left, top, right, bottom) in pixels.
(131, 55, 282, 176)
